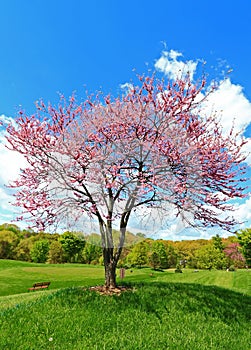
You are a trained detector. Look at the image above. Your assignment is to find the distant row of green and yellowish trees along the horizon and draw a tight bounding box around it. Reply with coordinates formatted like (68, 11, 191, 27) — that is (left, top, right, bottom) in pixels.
(0, 224, 251, 269)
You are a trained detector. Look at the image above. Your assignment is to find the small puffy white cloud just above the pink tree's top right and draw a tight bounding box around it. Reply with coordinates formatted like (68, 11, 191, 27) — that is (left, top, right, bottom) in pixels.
(155, 50, 198, 79)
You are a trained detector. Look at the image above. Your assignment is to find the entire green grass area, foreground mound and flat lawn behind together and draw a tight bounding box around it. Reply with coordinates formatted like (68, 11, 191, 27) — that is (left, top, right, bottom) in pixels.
(0, 260, 251, 350)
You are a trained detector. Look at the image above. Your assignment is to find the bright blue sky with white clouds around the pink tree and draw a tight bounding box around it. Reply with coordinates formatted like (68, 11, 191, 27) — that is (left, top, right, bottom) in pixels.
(0, 0, 251, 238)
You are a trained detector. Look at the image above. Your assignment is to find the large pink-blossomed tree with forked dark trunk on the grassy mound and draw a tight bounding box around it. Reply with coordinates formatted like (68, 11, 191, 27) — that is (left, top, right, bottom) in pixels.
(7, 76, 247, 288)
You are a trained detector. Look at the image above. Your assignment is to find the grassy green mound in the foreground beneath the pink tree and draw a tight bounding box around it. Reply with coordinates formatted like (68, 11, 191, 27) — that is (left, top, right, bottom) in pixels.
(0, 282, 251, 350)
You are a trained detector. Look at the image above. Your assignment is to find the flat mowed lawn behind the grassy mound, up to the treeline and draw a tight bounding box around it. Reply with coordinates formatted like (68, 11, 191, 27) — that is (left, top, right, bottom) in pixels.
(0, 260, 251, 309)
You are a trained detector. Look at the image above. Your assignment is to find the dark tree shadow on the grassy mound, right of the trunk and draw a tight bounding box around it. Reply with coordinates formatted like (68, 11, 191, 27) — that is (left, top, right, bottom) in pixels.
(113, 282, 251, 324)
